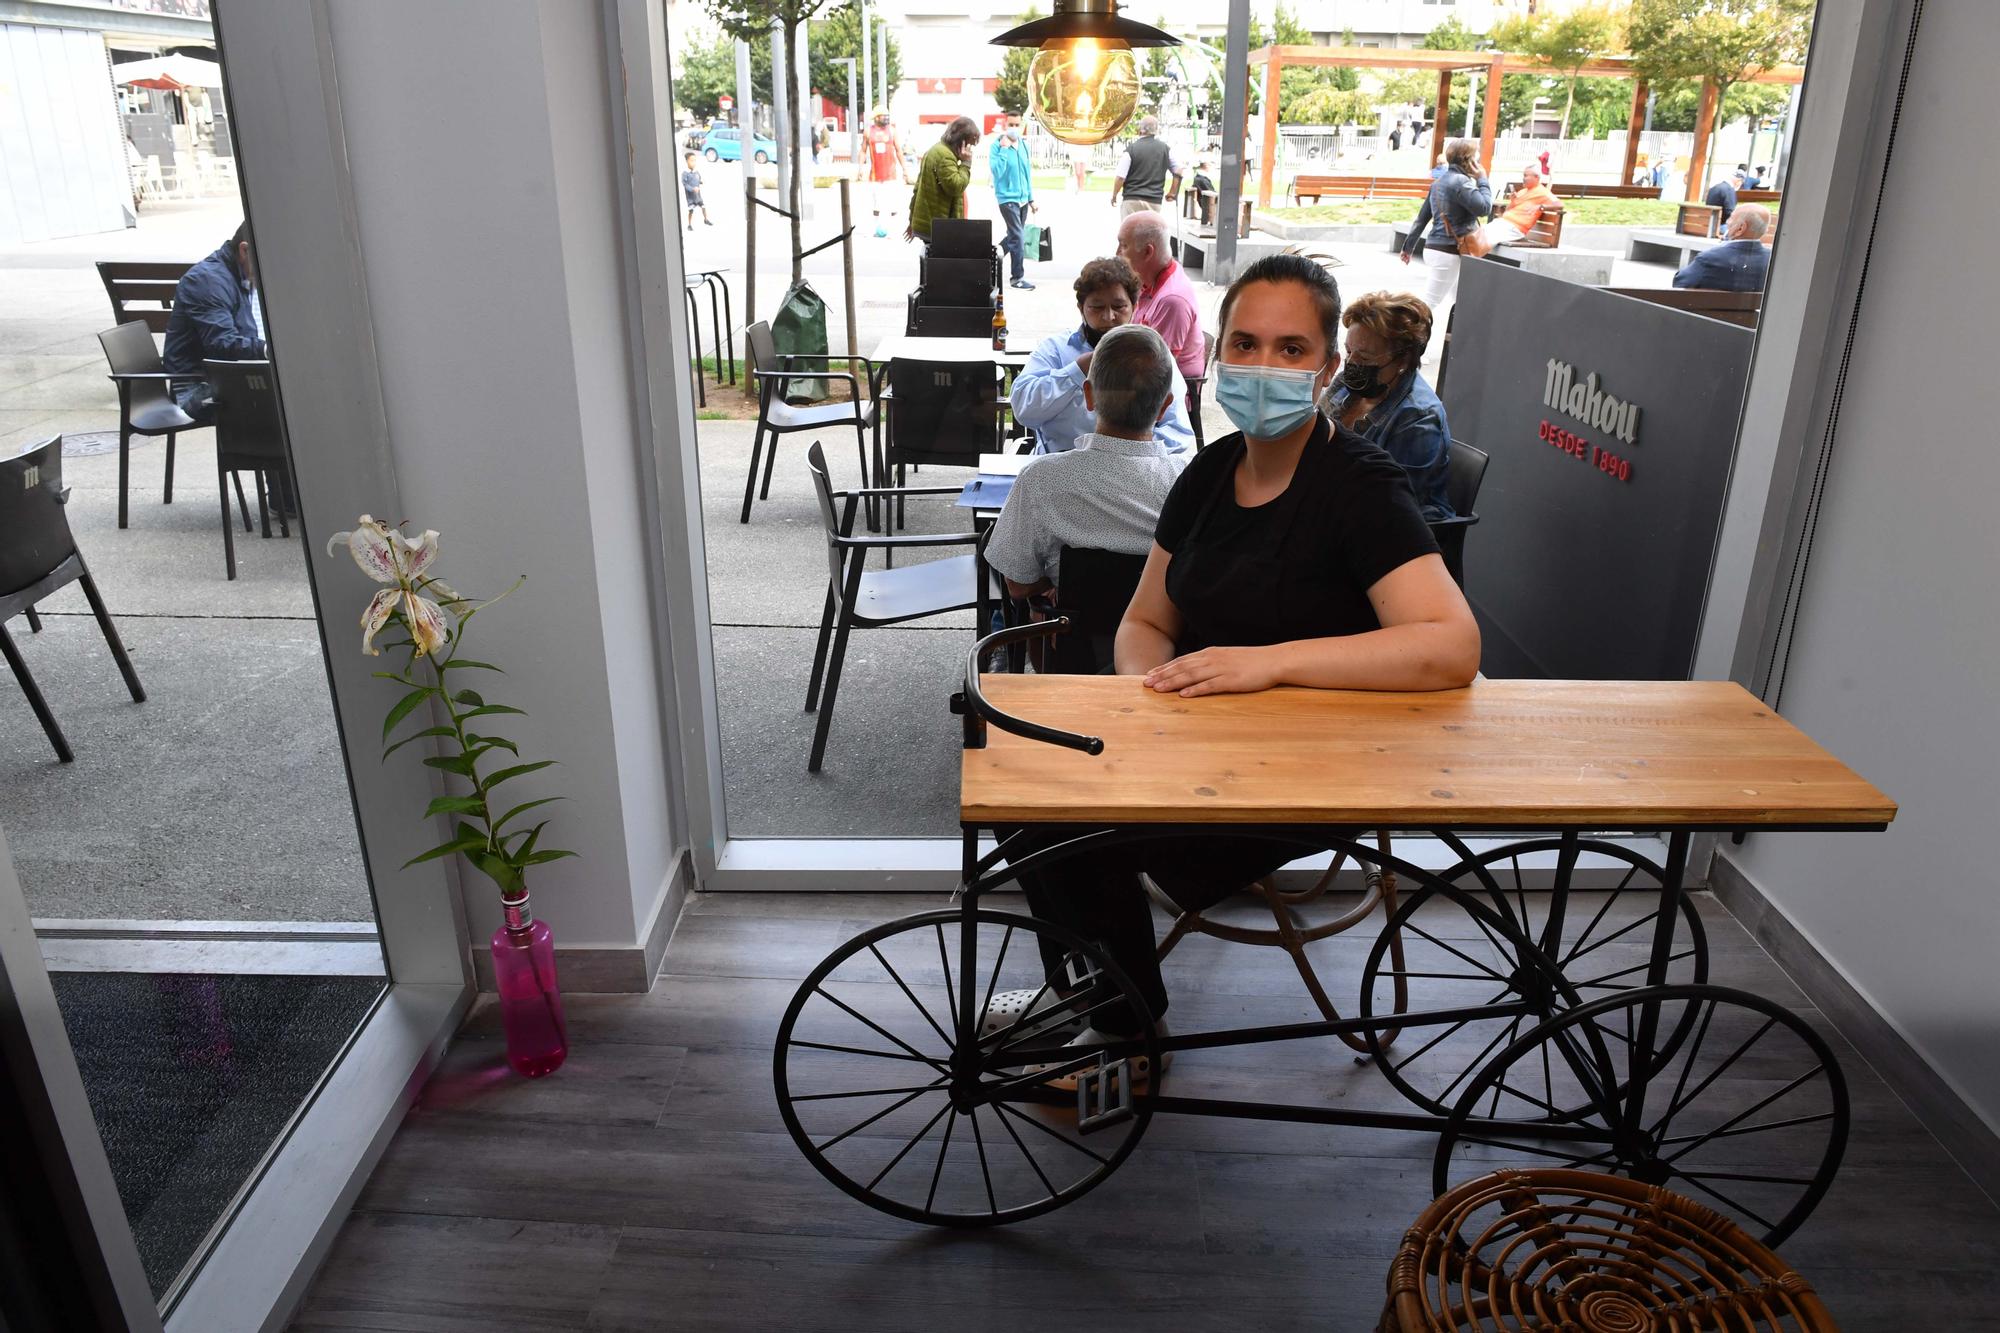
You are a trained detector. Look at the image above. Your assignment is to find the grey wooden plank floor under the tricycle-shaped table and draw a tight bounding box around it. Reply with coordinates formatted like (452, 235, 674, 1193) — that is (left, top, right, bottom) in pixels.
(292, 895, 2000, 1333)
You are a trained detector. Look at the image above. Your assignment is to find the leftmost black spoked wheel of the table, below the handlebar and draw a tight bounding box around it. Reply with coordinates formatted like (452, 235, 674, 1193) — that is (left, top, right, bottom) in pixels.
(774, 909, 1160, 1227)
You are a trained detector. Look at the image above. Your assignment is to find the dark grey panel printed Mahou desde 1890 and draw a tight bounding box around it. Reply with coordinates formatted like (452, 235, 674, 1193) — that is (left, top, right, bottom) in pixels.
(1440, 260, 1752, 681)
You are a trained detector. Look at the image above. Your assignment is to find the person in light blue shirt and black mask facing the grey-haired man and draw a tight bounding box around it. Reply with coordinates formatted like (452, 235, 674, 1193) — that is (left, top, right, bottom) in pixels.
(1010, 258, 1194, 454)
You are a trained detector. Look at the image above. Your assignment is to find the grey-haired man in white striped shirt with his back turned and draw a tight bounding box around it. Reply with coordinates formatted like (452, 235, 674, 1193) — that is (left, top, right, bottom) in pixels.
(986, 324, 1188, 598)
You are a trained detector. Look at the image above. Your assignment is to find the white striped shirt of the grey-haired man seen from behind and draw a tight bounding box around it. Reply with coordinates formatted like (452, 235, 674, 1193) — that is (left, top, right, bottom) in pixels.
(986, 434, 1188, 584)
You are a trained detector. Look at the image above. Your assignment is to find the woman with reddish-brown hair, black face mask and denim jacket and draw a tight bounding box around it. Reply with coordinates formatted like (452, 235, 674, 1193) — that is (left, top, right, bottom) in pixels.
(1322, 292, 1452, 522)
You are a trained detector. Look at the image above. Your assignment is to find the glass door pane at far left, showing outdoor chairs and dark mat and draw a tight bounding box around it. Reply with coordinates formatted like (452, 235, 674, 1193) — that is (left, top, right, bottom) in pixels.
(0, 15, 388, 1309)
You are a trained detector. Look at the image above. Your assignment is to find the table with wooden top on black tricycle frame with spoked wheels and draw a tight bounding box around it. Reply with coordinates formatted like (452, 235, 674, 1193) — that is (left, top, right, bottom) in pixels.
(774, 648, 1896, 1243)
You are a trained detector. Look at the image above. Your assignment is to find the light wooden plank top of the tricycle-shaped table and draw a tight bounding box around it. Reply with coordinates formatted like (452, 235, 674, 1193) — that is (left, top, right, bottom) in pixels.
(960, 675, 1896, 829)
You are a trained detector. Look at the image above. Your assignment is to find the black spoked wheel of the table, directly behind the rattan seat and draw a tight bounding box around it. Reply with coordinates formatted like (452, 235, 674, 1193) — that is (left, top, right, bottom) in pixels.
(1432, 985, 1848, 1245)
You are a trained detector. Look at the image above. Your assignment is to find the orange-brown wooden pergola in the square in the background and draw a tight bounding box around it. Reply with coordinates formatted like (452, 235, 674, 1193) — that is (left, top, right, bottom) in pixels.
(1250, 46, 1806, 208)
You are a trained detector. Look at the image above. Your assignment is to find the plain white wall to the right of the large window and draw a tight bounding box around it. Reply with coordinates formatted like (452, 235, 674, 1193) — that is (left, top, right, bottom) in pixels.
(1724, 4, 2000, 1131)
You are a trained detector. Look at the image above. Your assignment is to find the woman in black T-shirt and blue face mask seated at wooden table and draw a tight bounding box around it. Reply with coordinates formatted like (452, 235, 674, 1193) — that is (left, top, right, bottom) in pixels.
(988, 254, 1480, 1077)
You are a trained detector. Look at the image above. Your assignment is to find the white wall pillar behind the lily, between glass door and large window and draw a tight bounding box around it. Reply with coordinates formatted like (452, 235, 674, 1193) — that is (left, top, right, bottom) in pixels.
(328, 0, 682, 949)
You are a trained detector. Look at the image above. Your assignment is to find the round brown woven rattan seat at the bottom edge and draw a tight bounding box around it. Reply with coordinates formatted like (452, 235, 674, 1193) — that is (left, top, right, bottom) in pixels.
(1376, 1171, 1840, 1333)
